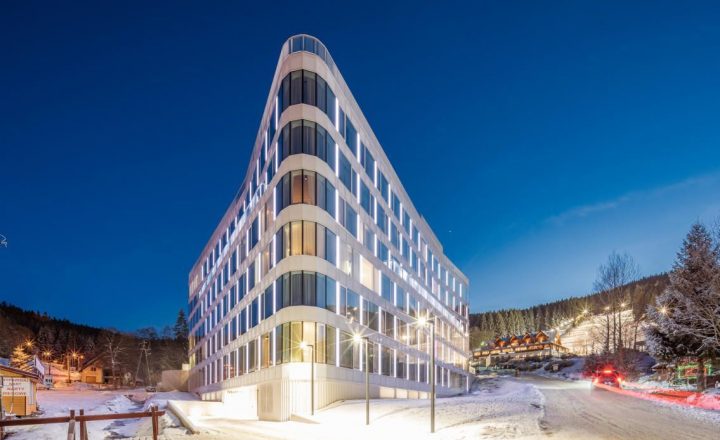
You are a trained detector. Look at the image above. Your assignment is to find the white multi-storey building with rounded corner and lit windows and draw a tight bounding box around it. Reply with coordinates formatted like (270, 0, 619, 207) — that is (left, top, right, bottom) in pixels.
(188, 35, 470, 420)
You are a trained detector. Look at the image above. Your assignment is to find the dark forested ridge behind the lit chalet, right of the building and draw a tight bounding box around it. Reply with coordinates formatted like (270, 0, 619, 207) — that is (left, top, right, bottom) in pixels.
(470, 274, 669, 348)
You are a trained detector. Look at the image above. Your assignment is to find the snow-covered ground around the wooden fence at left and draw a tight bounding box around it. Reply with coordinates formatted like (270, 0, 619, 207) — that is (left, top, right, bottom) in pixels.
(1, 384, 194, 440)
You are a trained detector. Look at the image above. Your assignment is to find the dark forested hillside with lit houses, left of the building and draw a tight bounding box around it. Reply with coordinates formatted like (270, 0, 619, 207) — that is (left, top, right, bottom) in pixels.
(0, 302, 188, 382)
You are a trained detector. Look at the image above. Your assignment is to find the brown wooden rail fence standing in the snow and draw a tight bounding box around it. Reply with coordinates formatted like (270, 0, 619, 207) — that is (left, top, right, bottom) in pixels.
(0, 405, 165, 440)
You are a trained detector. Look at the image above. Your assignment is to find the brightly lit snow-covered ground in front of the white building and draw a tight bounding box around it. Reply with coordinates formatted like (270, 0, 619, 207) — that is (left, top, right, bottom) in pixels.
(188, 378, 543, 440)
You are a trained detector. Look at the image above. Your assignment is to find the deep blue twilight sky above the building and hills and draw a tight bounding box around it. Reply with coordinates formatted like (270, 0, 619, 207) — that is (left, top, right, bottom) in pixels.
(0, 0, 720, 329)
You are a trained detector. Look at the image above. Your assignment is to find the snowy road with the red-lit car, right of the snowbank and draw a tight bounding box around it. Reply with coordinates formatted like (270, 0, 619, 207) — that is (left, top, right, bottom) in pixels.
(518, 376, 720, 440)
